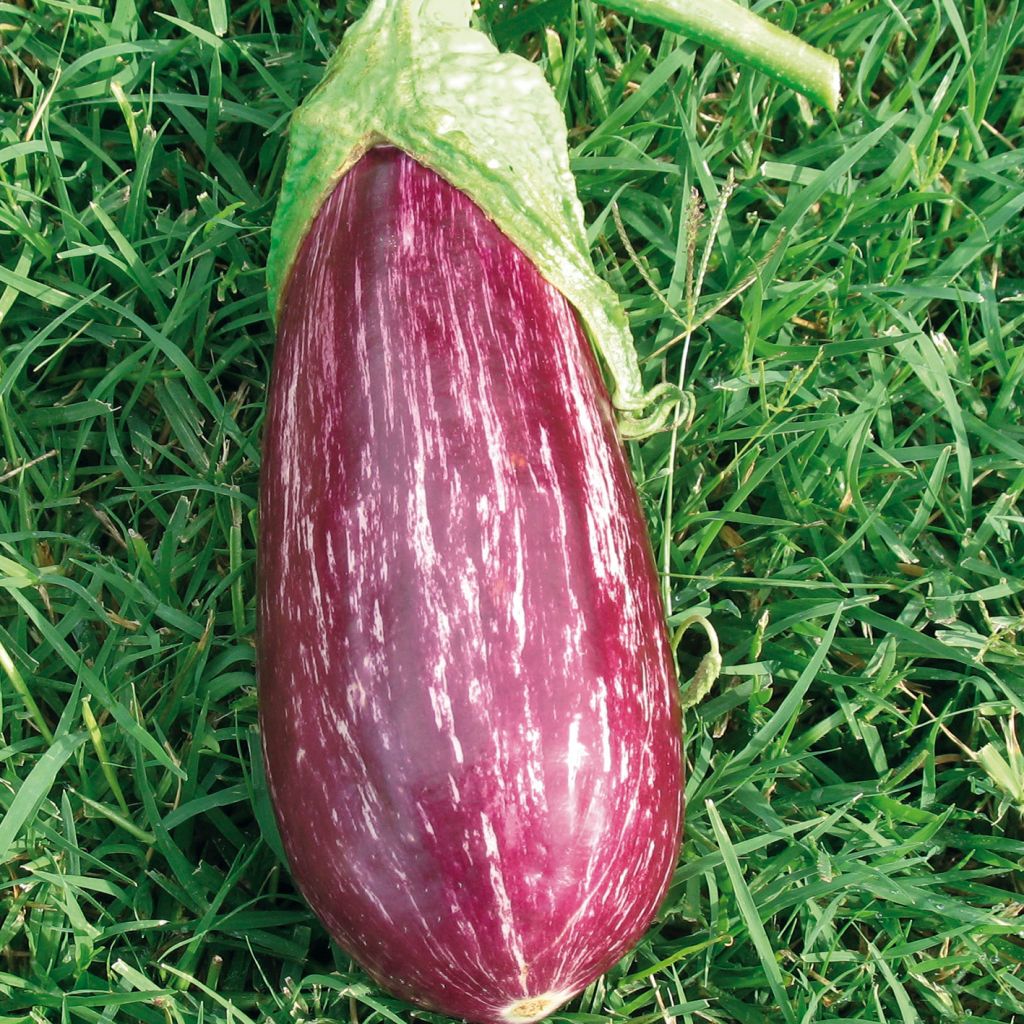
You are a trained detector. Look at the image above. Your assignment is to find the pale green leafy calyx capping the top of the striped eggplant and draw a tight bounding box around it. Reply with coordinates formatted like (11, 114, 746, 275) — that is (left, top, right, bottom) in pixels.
(267, 0, 678, 436)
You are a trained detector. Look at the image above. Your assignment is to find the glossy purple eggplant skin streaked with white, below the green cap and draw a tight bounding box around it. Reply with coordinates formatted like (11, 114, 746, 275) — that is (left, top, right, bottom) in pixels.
(258, 147, 682, 1024)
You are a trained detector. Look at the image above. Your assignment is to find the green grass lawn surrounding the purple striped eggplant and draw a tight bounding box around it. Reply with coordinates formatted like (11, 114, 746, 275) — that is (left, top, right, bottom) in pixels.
(0, 0, 1024, 1024)
